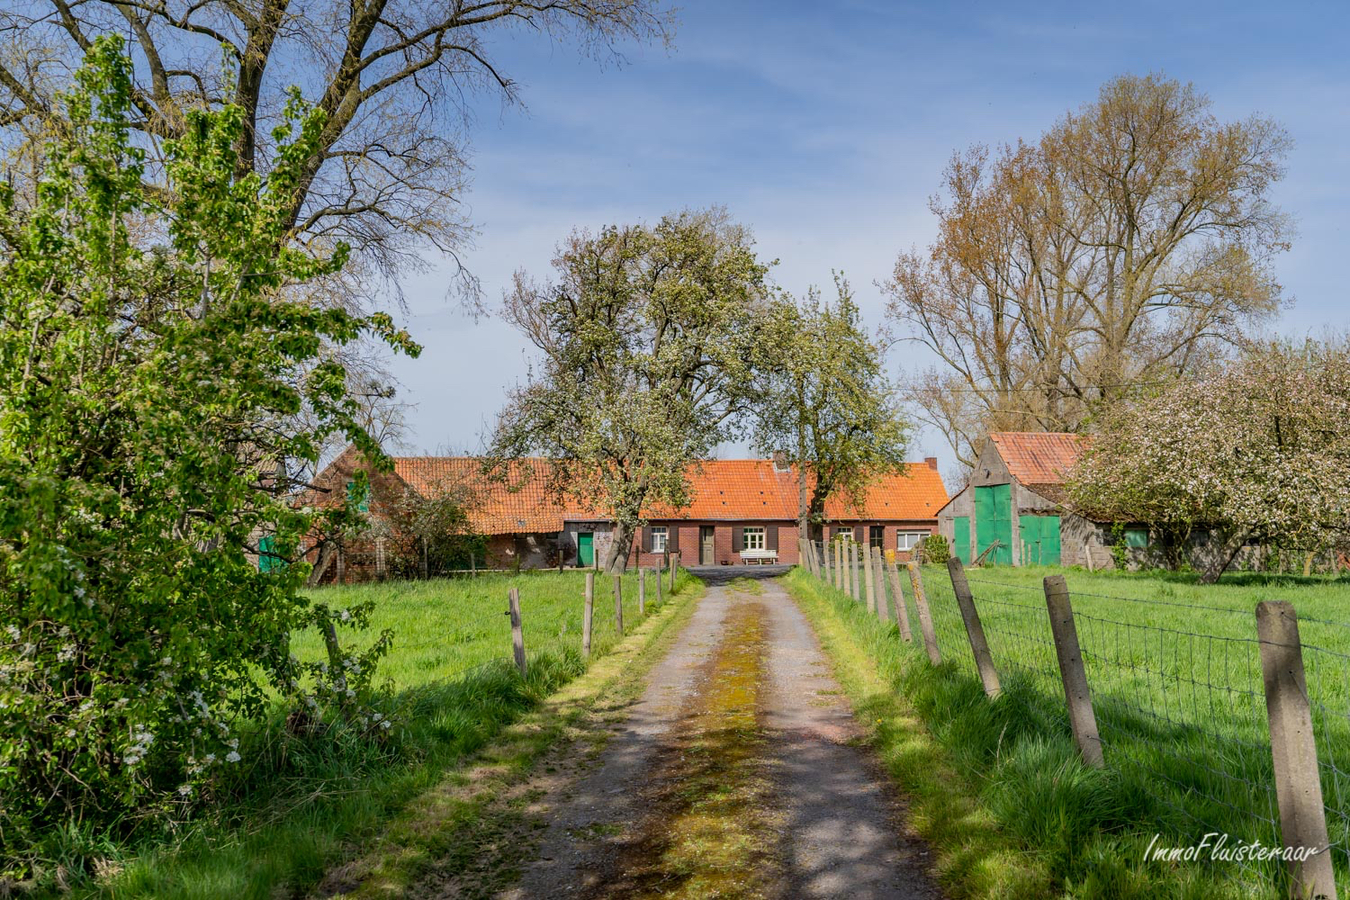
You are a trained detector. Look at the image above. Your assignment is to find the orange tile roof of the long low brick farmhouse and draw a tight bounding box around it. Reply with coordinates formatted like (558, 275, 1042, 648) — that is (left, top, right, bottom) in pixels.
(394, 456, 946, 534)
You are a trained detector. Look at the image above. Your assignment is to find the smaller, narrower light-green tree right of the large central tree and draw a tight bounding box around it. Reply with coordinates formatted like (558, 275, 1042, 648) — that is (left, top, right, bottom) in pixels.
(753, 277, 909, 541)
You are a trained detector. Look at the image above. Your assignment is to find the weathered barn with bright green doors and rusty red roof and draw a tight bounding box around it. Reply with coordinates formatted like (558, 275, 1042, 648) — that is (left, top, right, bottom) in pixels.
(938, 432, 1148, 568)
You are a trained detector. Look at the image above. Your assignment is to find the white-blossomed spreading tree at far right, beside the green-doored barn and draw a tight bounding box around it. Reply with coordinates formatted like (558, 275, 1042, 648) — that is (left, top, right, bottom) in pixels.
(1069, 340, 1350, 583)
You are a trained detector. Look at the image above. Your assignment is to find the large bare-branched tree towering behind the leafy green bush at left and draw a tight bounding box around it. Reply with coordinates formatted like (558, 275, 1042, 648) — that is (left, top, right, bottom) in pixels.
(0, 0, 672, 293)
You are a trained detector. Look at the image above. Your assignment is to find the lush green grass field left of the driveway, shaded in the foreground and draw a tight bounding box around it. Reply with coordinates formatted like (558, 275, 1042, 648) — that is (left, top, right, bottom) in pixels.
(72, 572, 694, 900)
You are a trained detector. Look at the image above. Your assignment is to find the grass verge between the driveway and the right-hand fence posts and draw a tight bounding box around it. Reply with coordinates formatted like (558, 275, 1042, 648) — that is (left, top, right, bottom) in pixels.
(784, 569, 1260, 900)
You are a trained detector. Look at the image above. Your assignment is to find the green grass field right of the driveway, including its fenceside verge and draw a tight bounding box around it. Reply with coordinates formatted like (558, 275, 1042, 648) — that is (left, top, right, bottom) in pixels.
(792, 568, 1350, 897)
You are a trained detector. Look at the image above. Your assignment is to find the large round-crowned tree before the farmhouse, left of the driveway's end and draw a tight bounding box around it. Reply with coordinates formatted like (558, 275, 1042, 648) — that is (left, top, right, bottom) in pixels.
(491, 209, 767, 571)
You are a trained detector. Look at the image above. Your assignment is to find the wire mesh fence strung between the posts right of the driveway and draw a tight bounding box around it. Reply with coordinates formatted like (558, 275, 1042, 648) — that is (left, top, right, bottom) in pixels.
(813, 546, 1350, 889)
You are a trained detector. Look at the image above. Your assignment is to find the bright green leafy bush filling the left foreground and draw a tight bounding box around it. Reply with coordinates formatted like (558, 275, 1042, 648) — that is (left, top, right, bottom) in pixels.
(0, 38, 417, 874)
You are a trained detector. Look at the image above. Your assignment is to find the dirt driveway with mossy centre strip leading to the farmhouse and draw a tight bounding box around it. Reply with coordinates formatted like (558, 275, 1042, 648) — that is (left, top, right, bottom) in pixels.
(491, 578, 941, 900)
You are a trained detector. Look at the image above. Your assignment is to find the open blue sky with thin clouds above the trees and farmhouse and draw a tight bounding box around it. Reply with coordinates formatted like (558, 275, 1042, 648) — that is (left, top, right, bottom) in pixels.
(380, 0, 1350, 471)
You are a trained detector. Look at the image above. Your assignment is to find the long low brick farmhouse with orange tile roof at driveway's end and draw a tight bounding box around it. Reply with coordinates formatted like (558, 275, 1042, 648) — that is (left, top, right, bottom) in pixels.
(303, 448, 946, 580)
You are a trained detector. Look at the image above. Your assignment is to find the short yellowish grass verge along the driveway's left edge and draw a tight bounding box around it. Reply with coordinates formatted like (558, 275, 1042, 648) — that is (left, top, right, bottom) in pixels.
(319, 576, 703, 900)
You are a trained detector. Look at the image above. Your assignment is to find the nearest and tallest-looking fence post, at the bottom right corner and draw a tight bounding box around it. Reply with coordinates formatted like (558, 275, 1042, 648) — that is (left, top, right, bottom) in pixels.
(1257, 600, 1337, 900)
